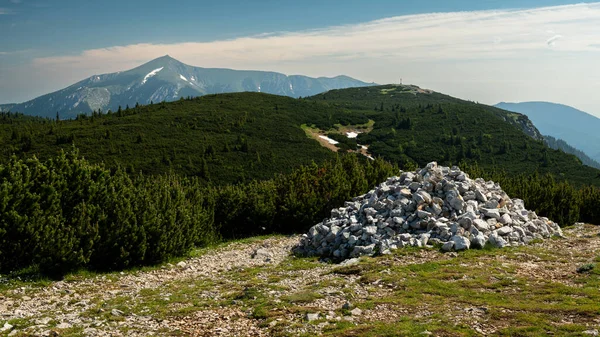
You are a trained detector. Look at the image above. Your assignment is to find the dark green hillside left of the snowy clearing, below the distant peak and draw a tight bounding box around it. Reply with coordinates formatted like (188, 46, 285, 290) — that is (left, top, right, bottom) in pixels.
(0, 93, 366, 184)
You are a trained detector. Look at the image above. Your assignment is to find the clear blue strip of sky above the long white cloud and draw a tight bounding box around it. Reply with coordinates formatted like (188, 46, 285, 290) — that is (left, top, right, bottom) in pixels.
(0, 0, 570, 55)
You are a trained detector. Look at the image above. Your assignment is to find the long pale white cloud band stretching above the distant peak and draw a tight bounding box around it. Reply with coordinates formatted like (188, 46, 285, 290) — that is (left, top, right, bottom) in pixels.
(36, 3, 600, 73)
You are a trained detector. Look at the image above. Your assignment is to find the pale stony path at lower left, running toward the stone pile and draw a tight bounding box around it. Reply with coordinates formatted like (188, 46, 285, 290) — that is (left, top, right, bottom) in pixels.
(0, 238, 297, 336)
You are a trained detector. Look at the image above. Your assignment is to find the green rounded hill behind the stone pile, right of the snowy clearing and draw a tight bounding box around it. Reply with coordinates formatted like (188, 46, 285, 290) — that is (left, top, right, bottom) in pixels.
(306, 85, 600, 186)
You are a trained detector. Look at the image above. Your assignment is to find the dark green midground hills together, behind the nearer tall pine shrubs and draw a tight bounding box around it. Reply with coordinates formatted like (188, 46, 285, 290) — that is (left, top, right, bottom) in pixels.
(0, 85, 600, 186)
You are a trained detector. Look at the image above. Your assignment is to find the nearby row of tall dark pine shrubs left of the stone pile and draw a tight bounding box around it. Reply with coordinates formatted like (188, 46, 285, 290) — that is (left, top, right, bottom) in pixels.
(0, 151, 397, 276)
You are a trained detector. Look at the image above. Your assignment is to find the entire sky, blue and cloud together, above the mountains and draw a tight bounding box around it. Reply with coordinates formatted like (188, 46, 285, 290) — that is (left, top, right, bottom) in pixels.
(0, 0, 600, 117)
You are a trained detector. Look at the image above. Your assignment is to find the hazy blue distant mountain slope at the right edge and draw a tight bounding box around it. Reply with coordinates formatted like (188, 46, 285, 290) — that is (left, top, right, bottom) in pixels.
(496, 102, 600, 161)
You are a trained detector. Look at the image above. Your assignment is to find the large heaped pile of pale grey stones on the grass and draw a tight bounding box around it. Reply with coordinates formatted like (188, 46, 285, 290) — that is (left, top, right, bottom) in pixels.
(295, 162, 562, 260)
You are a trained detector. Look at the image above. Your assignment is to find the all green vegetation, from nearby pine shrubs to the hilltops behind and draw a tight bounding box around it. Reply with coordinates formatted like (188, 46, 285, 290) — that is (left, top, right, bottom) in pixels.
(0, 86, 600, 276)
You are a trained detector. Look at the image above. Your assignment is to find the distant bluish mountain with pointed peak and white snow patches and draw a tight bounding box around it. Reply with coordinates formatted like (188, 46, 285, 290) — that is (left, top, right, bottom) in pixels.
(11, 55, 376, 119)
